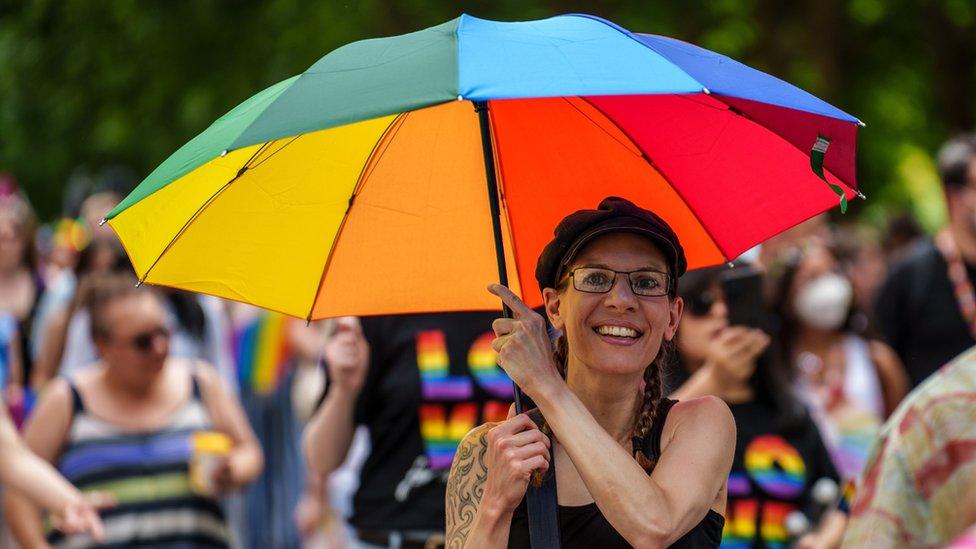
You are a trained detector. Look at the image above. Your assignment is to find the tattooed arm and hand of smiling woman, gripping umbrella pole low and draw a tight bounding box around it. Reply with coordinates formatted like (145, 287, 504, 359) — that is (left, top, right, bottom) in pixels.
(445, 411, 550, 549)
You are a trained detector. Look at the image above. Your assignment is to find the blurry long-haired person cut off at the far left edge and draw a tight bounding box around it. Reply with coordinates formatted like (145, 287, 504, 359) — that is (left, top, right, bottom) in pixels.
(0, 185, 44, 400)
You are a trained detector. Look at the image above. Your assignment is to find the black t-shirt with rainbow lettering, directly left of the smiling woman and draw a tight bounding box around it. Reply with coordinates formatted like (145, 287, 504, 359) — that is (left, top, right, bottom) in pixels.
(351, 311, 513, 531)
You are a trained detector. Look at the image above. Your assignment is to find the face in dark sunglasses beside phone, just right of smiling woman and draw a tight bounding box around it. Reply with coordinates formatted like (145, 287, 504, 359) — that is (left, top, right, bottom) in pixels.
(677, 279, 729, 369)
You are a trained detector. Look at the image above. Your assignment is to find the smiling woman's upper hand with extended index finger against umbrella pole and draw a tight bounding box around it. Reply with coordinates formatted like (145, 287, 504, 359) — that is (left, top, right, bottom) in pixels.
(488, 284, 561, 397)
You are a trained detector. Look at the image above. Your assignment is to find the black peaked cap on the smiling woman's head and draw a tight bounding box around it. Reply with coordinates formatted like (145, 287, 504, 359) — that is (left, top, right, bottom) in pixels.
(535, 196, 688, 291)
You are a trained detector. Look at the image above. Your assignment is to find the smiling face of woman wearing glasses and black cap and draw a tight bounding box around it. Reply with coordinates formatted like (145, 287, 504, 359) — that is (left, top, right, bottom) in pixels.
(543, 233, 682, 374)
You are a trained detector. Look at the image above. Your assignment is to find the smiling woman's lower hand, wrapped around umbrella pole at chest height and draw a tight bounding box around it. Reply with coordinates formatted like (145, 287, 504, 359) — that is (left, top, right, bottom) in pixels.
(483, 406, 550, 513)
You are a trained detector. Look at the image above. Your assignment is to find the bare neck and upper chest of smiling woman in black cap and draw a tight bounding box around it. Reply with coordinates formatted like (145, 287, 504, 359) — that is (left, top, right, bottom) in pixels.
(566, 363, 643, 441)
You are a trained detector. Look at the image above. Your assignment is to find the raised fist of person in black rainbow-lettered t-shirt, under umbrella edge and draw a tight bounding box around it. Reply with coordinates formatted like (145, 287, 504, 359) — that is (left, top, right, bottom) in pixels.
(323, 316, 369, 396)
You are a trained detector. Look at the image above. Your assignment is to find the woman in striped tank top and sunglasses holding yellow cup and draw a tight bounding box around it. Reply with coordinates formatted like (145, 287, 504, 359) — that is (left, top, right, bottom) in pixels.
(7, 274, 263, 547)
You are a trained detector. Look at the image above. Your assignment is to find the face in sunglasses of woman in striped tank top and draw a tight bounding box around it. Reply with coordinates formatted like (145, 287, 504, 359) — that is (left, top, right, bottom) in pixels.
(98, 293, 169, 382)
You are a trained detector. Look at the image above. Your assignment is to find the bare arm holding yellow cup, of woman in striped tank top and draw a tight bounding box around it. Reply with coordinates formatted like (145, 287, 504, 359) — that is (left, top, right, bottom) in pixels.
(196, 364, 264, 490)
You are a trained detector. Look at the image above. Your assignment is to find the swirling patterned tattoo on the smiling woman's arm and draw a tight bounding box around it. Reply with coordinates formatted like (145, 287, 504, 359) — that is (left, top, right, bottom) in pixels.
(446, 424, 494, 549)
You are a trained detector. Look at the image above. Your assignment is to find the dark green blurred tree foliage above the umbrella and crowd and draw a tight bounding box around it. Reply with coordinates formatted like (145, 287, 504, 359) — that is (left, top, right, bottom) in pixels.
(0, 0, 976, 228)
